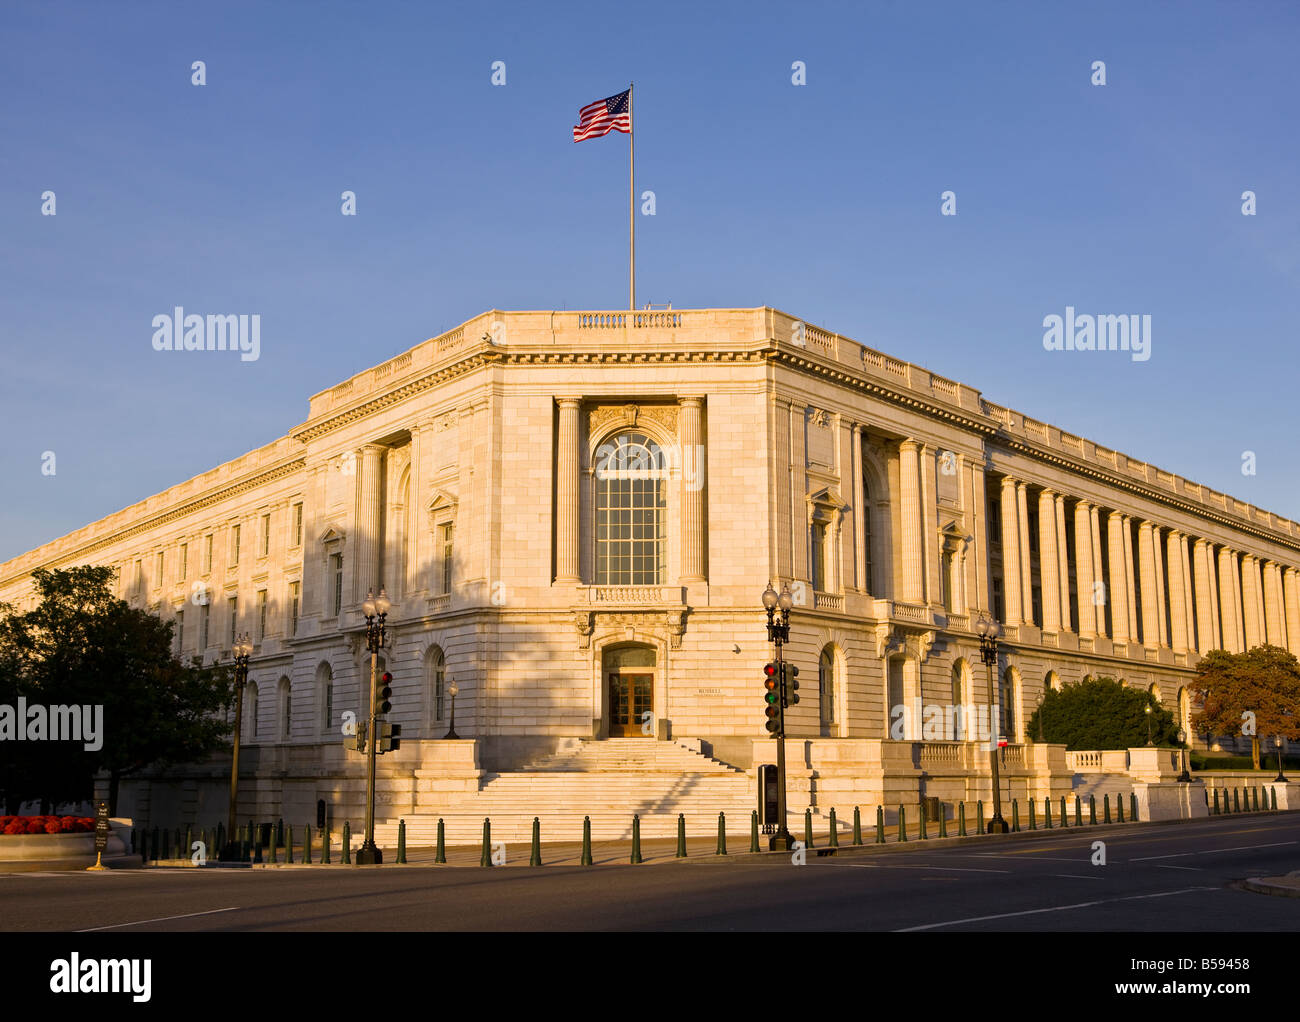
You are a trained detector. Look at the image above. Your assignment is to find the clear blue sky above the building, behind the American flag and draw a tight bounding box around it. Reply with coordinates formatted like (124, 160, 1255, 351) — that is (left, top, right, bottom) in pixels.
(0, 3, 1300, 559)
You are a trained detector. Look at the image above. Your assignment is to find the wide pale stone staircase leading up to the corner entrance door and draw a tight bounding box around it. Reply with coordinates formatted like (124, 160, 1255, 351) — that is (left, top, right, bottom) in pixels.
(376, 739, 757, 848)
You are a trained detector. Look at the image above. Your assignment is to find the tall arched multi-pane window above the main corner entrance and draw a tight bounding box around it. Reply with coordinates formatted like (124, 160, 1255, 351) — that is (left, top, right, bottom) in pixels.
(595, 430, 668, 585)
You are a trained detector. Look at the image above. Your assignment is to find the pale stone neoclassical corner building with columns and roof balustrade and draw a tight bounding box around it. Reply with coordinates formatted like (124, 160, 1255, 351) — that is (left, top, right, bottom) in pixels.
(0, 308, 1300, 836)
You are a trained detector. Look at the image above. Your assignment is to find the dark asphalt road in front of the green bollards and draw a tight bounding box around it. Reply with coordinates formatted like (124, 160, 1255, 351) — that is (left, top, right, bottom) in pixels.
(0, 814, 1300, 934)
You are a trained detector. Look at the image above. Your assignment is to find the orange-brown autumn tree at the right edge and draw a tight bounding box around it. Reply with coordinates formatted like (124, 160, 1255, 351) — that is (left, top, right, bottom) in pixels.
(1193, 645, 1300, 770)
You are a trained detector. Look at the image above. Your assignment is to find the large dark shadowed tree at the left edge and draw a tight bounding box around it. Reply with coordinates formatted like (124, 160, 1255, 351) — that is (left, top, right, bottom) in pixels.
(0, 566, 233, 813)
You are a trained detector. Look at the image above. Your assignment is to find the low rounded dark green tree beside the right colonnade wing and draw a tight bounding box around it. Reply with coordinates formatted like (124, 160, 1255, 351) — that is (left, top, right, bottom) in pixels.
(1027, 677, 1178, 750)
